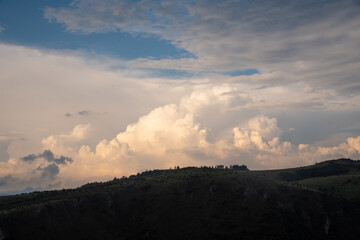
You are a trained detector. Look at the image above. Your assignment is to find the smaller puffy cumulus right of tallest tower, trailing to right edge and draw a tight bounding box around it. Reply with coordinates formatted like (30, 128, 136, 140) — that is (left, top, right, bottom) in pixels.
(233, 115, 360, 168)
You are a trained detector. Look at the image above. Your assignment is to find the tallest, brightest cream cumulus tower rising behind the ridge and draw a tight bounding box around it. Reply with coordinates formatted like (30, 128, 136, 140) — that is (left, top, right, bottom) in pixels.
(48, 86, 235, 178)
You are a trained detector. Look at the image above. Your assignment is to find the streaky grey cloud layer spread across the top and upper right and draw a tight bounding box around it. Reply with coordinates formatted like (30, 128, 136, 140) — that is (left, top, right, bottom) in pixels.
(45, 0, 360, 93)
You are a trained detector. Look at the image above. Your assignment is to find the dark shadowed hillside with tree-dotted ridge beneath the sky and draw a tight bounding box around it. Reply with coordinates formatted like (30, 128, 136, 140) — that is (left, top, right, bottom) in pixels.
(0, 159, 360, 240)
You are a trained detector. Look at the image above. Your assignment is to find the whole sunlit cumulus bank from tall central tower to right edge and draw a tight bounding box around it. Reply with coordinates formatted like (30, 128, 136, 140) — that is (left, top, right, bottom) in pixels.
(46, 85, 359, 176)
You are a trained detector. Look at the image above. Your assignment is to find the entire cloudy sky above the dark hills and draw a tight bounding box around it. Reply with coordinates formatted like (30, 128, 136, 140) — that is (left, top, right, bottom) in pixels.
(0, 0, 360, 195)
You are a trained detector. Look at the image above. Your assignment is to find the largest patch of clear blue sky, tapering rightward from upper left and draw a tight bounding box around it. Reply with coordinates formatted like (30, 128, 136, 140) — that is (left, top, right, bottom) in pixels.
(0, 0, 193, 60)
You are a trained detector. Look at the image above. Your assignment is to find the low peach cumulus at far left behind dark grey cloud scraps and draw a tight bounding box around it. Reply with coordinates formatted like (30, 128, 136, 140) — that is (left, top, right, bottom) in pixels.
(0, 124, 86, 194)
